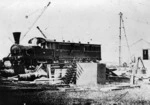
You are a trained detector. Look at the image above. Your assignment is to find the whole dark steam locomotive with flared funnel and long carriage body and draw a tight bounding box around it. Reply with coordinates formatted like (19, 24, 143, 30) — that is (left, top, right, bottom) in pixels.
(3, 32, 101, 72)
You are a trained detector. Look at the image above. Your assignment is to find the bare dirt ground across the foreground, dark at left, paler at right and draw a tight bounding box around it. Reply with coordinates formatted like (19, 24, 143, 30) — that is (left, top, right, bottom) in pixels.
(0, 83, 150, 105)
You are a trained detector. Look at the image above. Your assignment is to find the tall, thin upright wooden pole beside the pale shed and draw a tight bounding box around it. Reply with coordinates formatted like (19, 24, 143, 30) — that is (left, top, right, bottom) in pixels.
(119, 12, 123, 67)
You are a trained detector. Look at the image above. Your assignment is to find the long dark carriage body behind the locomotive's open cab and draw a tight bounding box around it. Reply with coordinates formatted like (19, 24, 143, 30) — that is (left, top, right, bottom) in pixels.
(43, 38, 101, 61)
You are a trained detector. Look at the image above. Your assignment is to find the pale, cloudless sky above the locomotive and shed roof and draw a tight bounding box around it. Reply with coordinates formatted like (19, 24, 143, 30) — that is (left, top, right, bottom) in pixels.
(0, 0, 150, 62)
